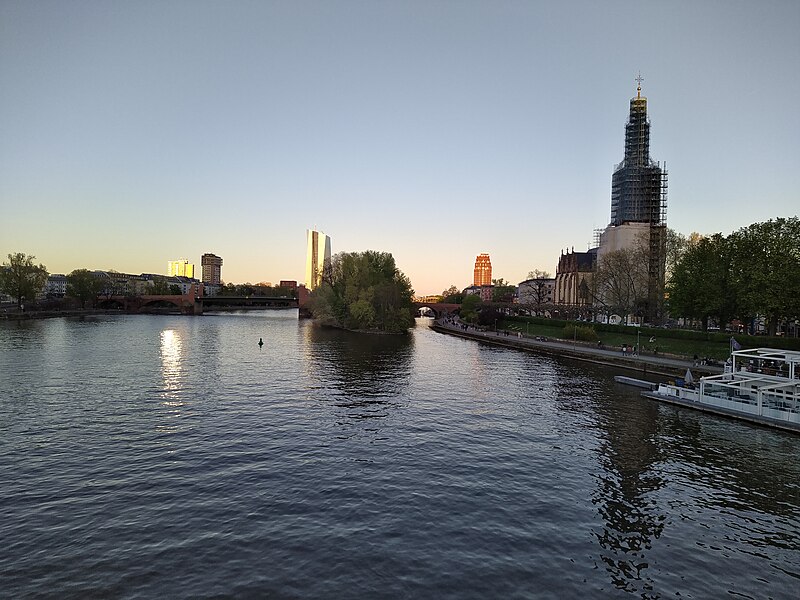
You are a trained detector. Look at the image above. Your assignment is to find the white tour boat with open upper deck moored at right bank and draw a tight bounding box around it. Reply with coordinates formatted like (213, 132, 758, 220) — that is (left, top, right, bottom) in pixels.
(642, 348, 800, 433)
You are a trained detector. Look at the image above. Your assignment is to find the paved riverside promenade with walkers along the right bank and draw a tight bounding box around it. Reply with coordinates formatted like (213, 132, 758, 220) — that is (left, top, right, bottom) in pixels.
(431, 319, 724, 378)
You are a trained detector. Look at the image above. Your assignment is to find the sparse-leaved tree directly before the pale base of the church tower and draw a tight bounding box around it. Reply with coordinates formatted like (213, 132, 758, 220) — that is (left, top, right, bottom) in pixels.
(585, 247, 648, 324)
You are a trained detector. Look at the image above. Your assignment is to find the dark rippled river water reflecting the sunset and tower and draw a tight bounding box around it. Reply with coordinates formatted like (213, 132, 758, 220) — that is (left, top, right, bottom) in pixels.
(0, 311, 800, 599)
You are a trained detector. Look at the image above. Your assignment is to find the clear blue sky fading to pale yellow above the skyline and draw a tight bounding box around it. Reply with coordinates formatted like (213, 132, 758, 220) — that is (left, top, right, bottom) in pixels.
(0, 0, 800, 294)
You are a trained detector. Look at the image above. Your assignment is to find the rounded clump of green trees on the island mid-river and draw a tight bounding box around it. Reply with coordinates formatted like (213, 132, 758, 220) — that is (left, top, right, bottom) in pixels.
(309, 250, 414, 333)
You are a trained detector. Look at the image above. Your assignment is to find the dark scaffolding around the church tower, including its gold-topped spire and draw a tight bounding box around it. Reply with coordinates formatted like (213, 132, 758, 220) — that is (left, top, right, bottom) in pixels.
(607, 76, 667, 322)
